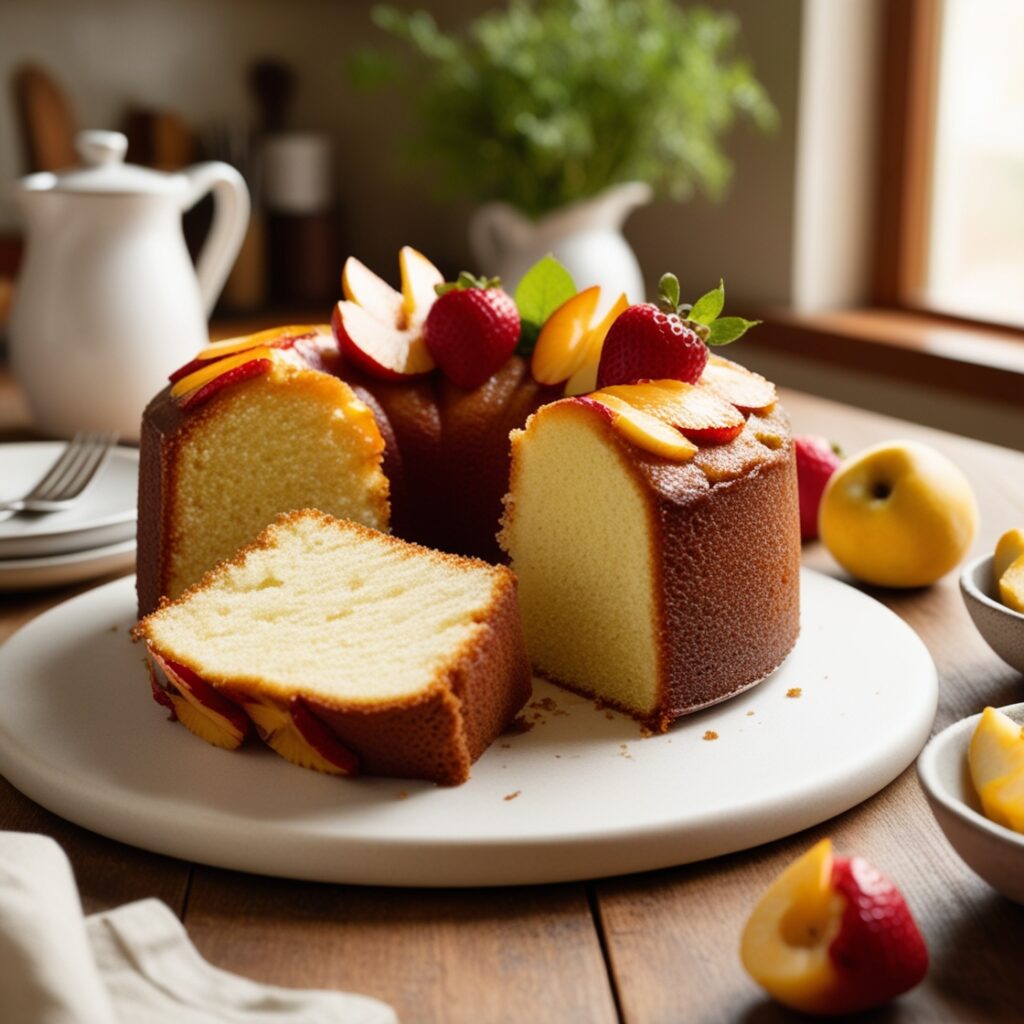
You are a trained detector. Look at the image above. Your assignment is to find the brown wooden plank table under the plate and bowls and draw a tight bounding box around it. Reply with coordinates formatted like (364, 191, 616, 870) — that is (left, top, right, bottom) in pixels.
(0, 370, 1024, 1024)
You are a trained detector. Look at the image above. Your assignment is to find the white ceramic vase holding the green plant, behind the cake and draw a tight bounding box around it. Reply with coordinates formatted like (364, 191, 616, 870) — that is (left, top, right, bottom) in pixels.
(469, 181, 652, 304)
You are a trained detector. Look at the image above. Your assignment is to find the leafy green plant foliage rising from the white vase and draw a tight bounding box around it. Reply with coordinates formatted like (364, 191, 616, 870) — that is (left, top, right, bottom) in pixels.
(352, 0, 776, 215)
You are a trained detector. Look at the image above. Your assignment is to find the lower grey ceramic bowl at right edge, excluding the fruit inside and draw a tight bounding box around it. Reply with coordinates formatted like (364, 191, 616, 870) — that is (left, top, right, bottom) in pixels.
(918, 703, 1024, 903)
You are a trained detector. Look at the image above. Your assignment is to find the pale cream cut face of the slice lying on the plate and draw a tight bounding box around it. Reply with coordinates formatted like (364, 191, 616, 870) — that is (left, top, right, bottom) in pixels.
(146, 513, 501, 708)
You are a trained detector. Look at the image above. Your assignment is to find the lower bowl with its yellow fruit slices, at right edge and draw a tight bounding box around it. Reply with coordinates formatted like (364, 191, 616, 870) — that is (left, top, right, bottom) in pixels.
(918, 703, 1024, 903)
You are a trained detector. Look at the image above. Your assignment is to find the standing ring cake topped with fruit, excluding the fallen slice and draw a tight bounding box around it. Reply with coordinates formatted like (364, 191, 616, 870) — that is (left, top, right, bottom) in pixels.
(138, 248, 800, 771)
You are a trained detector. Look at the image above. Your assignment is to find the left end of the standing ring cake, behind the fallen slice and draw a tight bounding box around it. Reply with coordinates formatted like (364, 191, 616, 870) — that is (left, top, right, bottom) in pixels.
(137, 327, 388, 615)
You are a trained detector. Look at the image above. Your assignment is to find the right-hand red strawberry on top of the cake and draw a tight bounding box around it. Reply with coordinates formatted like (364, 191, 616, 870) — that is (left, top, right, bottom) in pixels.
(597, 273, 708, 388)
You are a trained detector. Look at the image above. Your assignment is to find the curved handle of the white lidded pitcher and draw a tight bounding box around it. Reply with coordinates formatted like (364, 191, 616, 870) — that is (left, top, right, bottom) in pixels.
(184, 161, 249, 316)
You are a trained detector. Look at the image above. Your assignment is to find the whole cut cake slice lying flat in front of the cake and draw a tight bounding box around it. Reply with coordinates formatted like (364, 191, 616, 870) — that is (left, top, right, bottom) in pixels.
(135, 509, 530, 784)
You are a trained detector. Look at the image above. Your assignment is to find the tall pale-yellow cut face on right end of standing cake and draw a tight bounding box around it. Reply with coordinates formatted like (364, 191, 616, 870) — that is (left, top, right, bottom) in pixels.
(502, 406, 658, 715)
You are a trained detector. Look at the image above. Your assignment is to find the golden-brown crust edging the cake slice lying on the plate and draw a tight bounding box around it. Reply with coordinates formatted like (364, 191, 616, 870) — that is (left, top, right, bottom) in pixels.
(132, 509, 530, 785)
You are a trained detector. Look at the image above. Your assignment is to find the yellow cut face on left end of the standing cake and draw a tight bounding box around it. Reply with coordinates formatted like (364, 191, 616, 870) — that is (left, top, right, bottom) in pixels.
(164, 371, 388, 598)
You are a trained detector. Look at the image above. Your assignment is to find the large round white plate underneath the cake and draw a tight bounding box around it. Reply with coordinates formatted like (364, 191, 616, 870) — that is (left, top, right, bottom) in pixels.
(0, 571, 937, 886)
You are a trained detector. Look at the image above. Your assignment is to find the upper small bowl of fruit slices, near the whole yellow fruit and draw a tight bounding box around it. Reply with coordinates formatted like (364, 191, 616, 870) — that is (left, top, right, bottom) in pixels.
(961, 529, 1024, 672)
